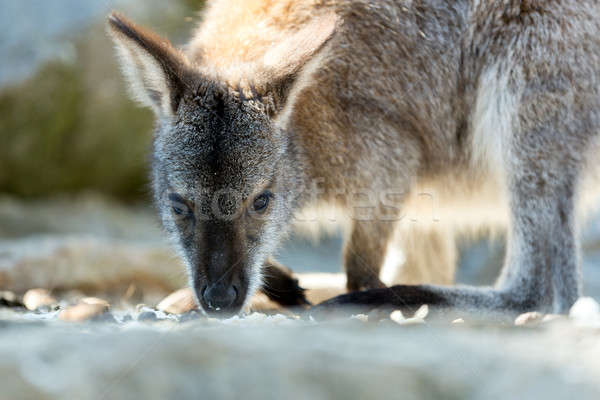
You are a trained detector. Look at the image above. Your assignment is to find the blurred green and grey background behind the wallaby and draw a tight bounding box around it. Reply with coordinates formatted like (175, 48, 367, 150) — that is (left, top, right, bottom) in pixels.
(0, 0, 600, 303)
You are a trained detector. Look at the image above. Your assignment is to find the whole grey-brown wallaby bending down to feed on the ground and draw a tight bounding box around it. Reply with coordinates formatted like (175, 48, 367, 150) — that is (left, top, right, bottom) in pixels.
(109, 0, 600, 314)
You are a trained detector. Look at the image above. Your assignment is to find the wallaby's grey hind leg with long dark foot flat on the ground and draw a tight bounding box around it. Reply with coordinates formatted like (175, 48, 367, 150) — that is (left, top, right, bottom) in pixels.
(315, 101, 586, 314)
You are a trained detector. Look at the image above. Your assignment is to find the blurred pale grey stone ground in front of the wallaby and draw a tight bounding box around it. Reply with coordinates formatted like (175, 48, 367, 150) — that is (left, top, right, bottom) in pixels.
(0, 309, 600, 399)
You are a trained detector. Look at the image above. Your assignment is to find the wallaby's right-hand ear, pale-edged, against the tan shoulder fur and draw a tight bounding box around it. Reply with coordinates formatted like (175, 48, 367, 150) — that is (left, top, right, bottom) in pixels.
(263, 13, 340, 113)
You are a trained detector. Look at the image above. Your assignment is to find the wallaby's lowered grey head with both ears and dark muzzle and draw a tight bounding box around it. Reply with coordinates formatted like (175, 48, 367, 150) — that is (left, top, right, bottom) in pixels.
(109, 14, 336, 314)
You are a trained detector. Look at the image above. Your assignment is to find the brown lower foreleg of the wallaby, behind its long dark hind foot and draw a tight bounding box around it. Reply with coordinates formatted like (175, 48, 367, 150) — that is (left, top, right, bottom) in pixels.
(344, 219, 394, 292)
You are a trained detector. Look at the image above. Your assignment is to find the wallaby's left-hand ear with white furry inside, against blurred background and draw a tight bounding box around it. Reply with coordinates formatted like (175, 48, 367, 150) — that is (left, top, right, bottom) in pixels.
(108, 12, 190, 117)
